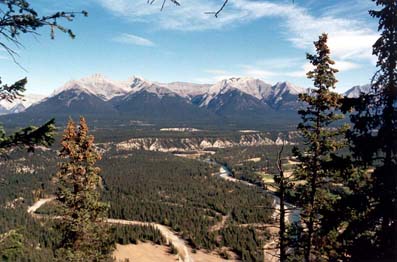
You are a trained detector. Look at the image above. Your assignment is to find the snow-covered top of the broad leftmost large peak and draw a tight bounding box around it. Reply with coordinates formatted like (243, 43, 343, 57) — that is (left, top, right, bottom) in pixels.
(51, 74, 130, 101)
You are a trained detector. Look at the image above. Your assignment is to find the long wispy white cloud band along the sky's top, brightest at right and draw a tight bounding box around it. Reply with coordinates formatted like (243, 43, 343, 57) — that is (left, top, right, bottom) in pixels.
(94, 0, 378, 62)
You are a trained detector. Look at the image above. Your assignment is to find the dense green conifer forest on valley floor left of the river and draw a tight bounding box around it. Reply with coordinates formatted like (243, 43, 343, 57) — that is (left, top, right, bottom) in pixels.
(1, 143, 273, 261)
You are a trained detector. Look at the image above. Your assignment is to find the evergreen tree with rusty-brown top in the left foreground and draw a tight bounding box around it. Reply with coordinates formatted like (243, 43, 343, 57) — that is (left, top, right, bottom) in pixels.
(56, 118, 111, 261)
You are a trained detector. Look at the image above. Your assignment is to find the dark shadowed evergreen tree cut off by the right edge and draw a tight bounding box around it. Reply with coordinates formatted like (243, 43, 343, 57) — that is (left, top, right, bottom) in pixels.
(346, 0, 397, 261)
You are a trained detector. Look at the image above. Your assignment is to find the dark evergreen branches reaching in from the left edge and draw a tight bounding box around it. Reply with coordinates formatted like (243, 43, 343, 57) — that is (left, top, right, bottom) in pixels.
(0, 0, 87, 155)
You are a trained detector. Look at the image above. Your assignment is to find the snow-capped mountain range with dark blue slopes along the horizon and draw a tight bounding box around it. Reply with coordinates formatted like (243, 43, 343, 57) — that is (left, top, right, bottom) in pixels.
(0, 74, 366, 127)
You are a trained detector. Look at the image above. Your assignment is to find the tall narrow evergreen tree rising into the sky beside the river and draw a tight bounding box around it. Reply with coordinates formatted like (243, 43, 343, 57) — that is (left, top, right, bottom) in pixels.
(293, 34, 346, 261)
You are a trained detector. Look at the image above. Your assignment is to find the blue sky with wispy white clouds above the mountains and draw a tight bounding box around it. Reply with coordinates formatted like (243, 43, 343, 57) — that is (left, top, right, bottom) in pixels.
(0, 0, 378, 94)
